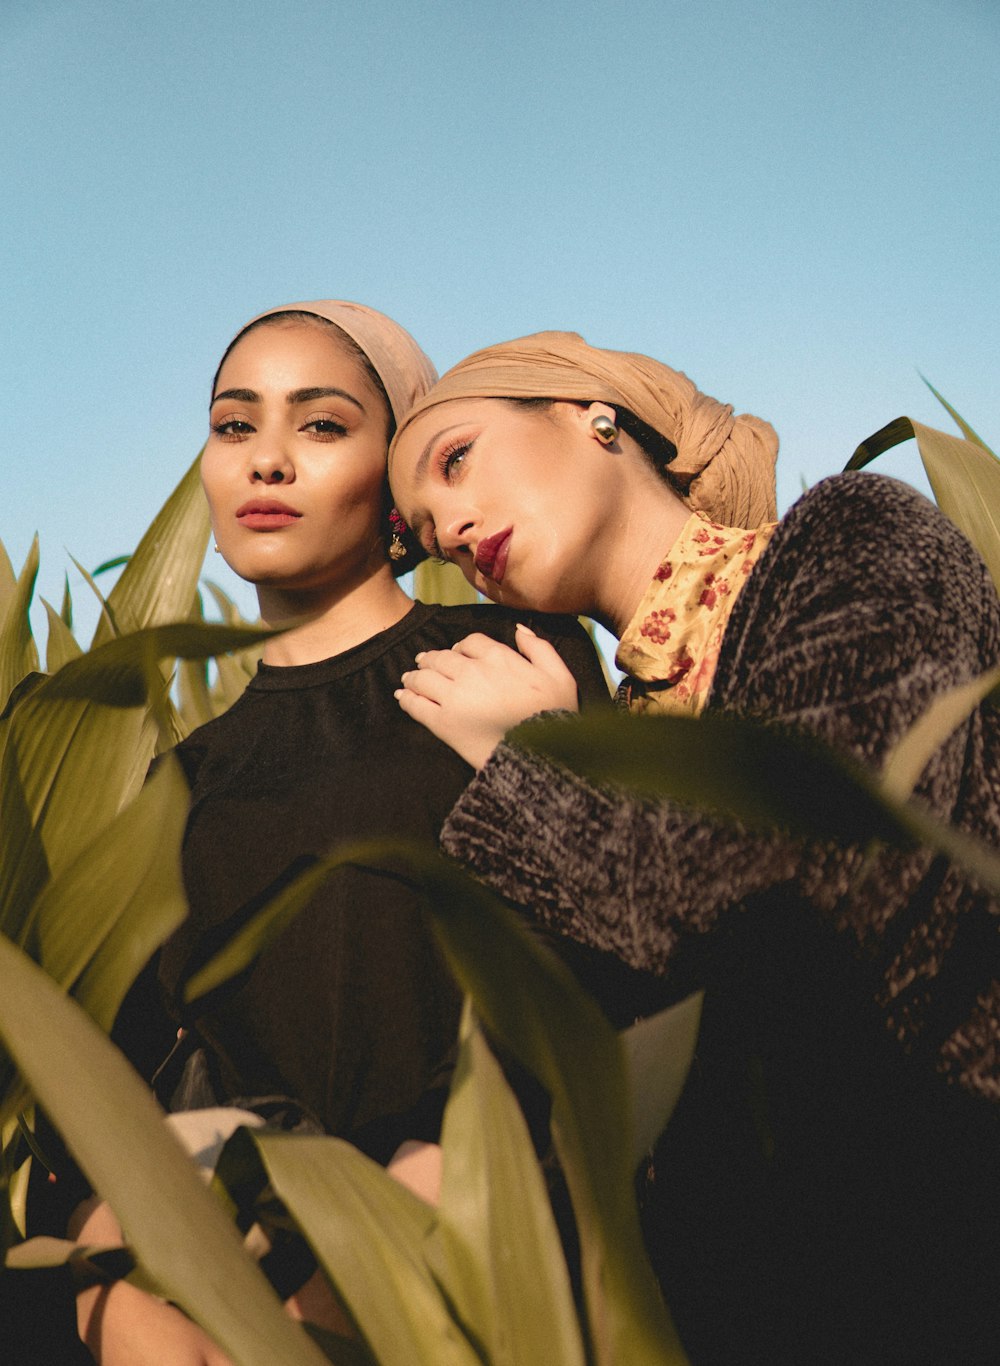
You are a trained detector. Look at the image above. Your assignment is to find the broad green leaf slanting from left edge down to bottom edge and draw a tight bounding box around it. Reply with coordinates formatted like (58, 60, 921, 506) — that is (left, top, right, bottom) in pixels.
(0, 937, 325, 1366)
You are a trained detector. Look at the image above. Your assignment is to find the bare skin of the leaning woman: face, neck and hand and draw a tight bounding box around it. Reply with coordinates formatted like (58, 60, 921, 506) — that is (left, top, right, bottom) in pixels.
(389, 399, 690, 768)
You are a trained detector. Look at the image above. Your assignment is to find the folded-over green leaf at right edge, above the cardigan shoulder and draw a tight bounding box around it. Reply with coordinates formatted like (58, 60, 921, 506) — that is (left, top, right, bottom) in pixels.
(847, 418, 1000, 589)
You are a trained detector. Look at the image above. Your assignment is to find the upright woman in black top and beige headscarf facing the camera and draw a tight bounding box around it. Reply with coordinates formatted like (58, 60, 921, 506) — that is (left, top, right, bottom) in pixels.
(64, 299, 608, 1366)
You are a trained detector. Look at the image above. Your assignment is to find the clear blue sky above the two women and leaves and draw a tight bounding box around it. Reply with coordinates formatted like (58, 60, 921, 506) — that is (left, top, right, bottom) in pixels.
(0, 0, 1000, 639)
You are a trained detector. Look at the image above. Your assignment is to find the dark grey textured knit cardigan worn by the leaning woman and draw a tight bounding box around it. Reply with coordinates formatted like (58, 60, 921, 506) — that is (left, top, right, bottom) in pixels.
(441, 473, 1000, 1101)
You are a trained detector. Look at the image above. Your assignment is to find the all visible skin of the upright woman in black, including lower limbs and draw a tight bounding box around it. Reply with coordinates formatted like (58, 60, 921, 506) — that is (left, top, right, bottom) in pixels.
(70, 318, 441, 1366)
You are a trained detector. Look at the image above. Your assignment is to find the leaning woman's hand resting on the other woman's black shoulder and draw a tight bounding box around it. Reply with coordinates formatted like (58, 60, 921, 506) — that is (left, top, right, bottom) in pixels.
(396, 623, 578, 769)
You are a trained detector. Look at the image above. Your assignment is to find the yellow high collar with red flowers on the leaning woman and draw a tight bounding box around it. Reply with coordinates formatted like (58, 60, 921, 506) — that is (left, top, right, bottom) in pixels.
(615, 512, 777, 713)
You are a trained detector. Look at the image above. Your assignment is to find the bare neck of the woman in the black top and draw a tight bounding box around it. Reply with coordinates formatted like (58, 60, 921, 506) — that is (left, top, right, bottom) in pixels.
(257, 567, 413, 665)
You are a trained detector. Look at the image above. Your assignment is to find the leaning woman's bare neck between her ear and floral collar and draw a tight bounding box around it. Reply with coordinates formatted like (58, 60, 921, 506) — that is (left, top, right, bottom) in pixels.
(592, 470, 691, 637)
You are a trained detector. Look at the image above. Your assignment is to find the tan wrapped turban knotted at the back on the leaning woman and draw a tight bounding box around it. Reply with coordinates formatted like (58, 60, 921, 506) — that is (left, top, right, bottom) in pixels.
(393, 332, 777, 527)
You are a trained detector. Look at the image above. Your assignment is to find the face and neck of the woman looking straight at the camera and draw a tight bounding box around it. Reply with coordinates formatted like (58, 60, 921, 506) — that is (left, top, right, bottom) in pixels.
(201, 321, 411, 664)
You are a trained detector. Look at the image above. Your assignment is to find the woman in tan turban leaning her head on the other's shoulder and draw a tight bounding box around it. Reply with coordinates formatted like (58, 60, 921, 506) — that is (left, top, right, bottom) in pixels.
(389, 332, 1000, 1366)
